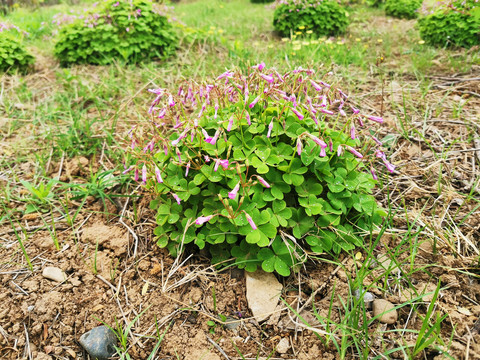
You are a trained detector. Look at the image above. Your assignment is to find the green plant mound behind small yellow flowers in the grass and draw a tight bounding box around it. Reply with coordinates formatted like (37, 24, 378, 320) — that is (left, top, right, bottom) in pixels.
(273, 0, 349, 36)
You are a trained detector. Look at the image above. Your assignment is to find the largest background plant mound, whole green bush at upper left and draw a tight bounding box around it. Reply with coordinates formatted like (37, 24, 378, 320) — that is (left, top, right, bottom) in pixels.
(55, 0, 177, 65)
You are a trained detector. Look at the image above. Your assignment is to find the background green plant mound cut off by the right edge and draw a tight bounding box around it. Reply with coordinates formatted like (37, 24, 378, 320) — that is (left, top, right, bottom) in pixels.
(418, 0, 480, 48)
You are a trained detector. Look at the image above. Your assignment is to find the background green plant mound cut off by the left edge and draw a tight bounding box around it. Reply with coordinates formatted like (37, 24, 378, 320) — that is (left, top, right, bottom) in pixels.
(0, 23, 35, 72)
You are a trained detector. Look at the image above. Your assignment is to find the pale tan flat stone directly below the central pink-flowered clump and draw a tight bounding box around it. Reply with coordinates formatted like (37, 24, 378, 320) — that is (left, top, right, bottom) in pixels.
(245, 270, 283, 322)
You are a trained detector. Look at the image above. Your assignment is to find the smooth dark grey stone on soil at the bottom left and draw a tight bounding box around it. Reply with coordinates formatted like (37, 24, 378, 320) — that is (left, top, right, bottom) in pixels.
(79, 326, 117, 360)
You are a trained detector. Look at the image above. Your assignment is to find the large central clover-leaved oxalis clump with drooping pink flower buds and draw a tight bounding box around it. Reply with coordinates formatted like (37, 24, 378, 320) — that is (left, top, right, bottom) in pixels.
(125, 63, 394, 276)
